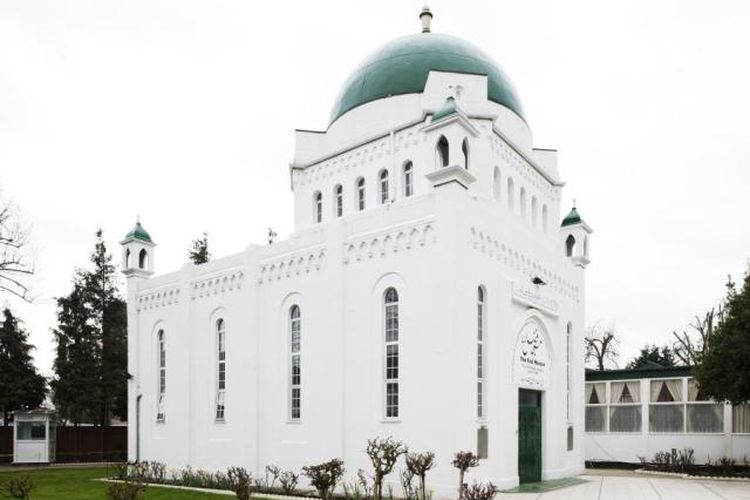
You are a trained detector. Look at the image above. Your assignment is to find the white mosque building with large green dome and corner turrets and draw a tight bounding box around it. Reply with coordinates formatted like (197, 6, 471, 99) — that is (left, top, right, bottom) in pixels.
(122, 9, 591, 496)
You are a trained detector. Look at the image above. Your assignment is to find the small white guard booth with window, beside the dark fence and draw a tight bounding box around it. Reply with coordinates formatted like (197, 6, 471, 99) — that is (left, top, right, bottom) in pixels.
(13, 410, 56, 464)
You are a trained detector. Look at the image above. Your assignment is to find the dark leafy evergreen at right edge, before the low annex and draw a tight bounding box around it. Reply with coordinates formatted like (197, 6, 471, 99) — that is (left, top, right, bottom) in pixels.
(695, 267, 750, 404)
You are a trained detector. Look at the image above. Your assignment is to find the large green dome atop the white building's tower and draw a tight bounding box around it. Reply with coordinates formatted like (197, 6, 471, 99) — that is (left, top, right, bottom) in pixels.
(331, 33, 524, 123)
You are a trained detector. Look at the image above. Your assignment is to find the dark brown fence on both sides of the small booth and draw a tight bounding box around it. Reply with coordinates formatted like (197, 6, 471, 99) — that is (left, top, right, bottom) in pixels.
(0, 427, 128, 462)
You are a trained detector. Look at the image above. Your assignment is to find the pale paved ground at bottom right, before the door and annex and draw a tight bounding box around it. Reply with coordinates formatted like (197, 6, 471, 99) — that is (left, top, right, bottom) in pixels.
(495, 476, 750, 500)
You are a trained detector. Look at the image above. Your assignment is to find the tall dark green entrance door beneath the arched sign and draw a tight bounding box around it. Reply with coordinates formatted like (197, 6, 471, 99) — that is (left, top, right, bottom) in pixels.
(518, 389, 542, 483)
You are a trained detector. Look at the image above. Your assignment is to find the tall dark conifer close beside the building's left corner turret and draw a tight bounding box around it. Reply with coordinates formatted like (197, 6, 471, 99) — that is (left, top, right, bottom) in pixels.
(51, 229, 128, 425)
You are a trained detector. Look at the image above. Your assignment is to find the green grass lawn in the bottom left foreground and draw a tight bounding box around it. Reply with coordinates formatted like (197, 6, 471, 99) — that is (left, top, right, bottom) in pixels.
(0, 467, 232, 500)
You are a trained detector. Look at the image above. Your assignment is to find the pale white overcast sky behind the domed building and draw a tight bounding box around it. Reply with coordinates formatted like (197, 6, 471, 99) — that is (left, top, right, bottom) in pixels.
(0, 0, 750, 374)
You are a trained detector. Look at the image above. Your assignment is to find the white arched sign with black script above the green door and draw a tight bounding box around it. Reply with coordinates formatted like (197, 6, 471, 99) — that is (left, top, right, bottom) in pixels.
(513, 320, 550, 390)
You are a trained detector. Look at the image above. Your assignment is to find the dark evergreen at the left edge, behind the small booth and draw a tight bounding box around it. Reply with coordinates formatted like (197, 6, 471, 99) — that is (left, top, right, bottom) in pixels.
(0, 308, 47, 425)
